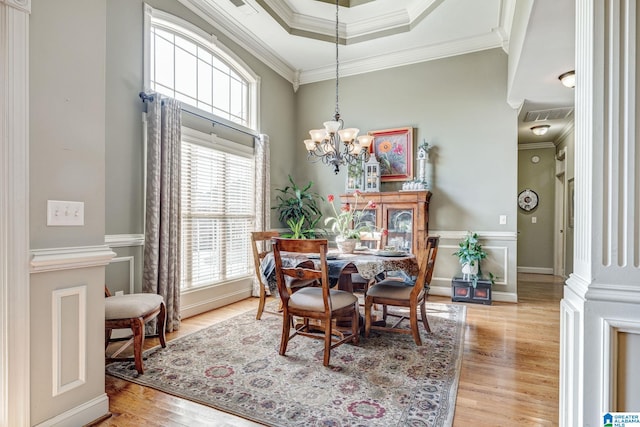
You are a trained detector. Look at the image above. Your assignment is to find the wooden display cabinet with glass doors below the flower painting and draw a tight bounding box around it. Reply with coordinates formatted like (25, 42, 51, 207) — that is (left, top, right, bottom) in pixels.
(340, 190, 431, 254)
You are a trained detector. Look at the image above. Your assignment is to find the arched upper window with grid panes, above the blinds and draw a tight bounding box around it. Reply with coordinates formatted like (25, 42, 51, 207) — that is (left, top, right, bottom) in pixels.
(144, 6, 259, 130)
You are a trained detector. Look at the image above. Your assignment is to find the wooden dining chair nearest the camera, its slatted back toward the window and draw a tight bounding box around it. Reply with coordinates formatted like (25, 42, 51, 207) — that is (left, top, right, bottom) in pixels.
(273, 238, 360, 366)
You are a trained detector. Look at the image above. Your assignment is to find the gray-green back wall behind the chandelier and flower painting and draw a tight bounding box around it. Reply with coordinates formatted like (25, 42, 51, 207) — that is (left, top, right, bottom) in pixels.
(292, 49, 517, 231)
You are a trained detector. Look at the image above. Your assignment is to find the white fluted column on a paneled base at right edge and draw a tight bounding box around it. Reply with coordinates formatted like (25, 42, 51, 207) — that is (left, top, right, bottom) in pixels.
(559, 0, 640, 427)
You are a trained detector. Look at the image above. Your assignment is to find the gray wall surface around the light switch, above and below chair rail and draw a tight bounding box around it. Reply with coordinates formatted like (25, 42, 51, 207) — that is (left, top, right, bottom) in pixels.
(29, 0, 108, 425)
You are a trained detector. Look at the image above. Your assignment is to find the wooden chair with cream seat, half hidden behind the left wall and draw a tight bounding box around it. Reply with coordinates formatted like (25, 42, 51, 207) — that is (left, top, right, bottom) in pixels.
(104, 286, 167, 374)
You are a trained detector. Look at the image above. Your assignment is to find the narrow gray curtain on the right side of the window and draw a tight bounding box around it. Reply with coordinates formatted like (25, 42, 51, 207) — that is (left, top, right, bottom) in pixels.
(252, 134, 271, 296)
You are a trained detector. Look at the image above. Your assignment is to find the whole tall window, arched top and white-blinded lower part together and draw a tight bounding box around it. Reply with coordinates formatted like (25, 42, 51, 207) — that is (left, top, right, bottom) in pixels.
(144, 5, 260, 298)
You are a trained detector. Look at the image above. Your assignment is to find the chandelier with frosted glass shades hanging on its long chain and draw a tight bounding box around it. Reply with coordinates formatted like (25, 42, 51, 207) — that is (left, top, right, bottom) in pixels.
(304, 0, 373, 174)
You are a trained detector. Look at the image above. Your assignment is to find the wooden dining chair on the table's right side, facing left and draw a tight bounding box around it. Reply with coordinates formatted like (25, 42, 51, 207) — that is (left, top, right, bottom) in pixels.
(364, 236, 440, 346)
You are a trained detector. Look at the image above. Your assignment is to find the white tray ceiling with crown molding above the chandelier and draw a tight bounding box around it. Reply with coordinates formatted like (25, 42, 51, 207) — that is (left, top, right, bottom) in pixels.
(180, 0, 575, 143)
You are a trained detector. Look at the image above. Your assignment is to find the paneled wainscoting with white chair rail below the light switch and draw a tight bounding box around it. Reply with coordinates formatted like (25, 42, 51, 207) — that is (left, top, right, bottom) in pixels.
(30, 245, 115, 426)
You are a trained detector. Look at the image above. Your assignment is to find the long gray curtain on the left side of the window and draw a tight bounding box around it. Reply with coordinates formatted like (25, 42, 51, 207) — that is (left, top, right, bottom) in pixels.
(142, 94, 181, 333)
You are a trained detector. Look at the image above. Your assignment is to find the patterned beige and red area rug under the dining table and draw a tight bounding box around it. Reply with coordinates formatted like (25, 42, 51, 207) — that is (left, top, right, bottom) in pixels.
(107, 303, 466, 427)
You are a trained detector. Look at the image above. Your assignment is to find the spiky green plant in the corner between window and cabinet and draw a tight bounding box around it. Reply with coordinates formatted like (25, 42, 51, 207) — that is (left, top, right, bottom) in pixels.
(271, 175, 322, 239)
